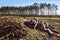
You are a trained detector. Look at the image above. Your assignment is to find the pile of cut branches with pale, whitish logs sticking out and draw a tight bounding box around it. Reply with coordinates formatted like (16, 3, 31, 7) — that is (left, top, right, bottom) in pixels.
(24, 18, 60, 38)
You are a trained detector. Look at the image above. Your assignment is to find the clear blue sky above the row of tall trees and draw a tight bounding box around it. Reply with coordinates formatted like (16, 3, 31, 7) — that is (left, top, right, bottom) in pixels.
(0, 0, 60, 14)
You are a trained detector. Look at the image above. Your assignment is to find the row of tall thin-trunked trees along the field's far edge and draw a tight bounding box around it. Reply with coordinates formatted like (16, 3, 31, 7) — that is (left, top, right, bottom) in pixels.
(0, 3, 58, 15)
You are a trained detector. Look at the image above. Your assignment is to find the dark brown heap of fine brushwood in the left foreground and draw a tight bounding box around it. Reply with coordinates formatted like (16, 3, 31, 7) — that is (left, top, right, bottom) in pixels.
(0, 17, 28, 40)
